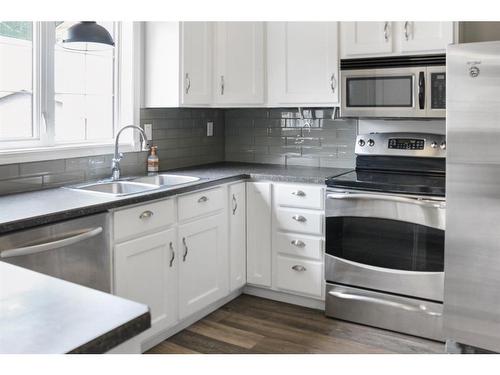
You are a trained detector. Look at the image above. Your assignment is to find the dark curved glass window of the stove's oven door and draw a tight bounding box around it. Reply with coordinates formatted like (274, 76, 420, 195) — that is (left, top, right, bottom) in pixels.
(326, 217, 444, 272)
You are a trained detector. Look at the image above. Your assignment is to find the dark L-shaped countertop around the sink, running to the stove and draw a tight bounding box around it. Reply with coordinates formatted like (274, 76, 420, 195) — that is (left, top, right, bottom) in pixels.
(0, 162, 350, 234)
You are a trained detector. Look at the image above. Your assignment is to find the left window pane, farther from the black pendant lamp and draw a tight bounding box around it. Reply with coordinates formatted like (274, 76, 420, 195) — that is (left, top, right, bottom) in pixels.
(0, 22, 33, 141)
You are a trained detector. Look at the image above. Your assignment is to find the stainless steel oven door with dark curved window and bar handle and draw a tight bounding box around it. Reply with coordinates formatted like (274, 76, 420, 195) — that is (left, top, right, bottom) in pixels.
(325, 189, 445, 301)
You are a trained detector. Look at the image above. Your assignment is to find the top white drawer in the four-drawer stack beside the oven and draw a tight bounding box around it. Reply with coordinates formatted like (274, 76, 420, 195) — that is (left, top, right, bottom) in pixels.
(276, 184, 324, 210)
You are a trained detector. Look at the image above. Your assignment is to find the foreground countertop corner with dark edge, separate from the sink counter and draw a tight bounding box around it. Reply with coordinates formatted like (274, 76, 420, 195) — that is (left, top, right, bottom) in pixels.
(0, 262, 151, 354)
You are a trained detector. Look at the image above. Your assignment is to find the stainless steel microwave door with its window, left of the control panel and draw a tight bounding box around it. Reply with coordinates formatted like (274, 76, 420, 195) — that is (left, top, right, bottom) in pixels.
(341, 67, 426, 117)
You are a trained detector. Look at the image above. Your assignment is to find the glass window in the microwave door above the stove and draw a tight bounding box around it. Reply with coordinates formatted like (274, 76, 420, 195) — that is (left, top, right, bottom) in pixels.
(346, 75, 413, 107)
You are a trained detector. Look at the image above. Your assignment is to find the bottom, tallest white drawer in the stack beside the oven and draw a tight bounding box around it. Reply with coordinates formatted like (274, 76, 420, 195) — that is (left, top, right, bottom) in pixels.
(276, 256, 323, 297)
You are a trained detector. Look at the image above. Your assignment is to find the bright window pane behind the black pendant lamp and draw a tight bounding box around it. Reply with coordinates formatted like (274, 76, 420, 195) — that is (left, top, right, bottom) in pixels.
(54, 22, 116, 143)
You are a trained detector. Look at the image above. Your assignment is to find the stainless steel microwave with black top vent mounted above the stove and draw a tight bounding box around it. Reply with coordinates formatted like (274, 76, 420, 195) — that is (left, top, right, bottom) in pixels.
(340, 54, 446, 118)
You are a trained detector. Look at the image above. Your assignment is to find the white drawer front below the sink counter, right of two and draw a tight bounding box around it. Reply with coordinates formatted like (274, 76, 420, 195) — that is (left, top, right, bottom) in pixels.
(178, 187, 224, 221)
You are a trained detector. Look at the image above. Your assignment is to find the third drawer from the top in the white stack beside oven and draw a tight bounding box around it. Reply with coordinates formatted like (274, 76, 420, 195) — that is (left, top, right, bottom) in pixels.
(276, 233, 323, 260)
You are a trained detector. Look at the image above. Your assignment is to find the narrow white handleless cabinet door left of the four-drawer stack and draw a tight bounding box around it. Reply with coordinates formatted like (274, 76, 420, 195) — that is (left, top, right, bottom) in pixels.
(247, 182, 272, 286)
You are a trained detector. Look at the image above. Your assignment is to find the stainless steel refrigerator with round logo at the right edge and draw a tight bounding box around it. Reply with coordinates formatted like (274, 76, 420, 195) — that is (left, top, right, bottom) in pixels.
(444, 42, 500, 352)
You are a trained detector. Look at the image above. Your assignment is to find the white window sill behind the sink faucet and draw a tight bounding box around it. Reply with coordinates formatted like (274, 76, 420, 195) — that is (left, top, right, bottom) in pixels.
(0, 143, 138, 165)
